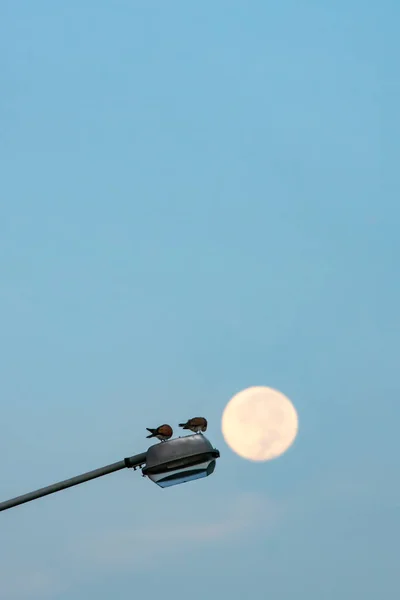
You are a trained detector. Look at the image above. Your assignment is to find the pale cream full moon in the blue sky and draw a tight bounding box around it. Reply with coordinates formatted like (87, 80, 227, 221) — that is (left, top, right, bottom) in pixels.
(222, 386, 299, 462)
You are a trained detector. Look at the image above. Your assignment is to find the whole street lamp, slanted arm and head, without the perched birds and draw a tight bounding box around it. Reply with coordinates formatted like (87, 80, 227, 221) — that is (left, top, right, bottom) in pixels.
(0, 434, 220, 512)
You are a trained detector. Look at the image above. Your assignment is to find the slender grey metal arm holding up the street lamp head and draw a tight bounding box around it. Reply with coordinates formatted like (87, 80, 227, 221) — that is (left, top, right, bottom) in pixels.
(0, 452, 147, 512)
